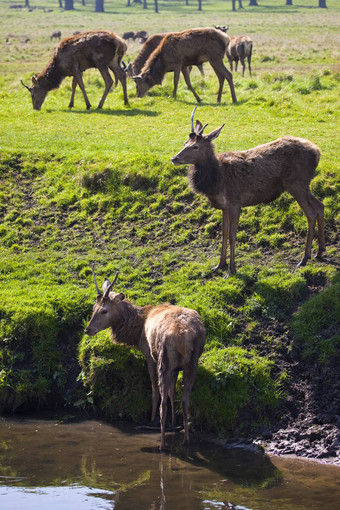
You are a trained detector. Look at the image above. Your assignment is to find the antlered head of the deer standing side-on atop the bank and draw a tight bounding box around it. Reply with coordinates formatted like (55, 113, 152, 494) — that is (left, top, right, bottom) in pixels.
(171, 106, 224, 165)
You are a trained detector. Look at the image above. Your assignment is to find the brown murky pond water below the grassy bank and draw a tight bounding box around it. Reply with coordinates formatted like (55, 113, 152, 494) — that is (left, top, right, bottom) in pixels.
(0, 418, 340, 510)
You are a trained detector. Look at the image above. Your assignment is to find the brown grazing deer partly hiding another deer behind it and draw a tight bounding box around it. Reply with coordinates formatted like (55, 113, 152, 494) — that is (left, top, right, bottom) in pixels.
(133, 28, 237, 103)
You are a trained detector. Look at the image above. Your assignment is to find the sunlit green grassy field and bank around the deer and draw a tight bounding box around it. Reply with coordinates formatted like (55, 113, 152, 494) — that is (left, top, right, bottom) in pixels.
(0, 0, 340, 433)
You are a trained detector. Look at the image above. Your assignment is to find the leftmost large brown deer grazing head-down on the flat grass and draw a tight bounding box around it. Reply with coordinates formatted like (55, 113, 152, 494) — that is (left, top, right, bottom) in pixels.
(21, 30, 129, 110)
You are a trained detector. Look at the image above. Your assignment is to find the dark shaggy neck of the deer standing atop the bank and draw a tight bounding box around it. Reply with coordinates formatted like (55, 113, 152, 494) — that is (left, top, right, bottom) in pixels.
(189, 152, 221, 198)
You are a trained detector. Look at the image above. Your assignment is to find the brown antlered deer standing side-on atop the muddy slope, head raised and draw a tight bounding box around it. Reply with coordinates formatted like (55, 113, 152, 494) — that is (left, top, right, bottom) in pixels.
(172, 108, 325, 277)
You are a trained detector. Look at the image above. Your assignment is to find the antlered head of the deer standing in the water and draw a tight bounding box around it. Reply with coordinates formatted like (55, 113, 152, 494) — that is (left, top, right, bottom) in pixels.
(84, 264, 125, 336)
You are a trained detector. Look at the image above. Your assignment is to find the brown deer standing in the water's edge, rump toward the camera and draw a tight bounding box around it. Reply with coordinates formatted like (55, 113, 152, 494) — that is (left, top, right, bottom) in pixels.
(85, 266, 205, 449)
